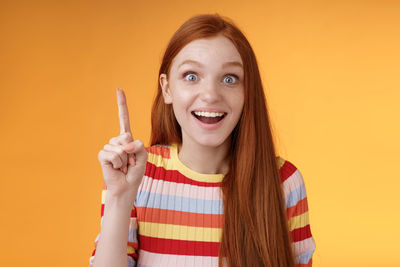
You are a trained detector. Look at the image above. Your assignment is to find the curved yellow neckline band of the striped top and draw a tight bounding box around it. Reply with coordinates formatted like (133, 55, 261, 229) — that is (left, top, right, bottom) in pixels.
(170, 143, 225, 183)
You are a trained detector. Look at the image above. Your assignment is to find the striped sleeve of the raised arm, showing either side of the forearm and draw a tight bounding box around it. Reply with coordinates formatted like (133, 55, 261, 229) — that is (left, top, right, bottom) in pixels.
(89, 182, 139, 267)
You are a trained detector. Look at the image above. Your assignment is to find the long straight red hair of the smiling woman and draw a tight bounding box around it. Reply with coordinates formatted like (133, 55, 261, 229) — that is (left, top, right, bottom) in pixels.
(150, 14, 294, 267)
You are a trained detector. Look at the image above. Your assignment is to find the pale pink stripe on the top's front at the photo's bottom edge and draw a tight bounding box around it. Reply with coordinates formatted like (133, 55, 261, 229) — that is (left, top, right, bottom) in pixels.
(138, 250, 218, 267)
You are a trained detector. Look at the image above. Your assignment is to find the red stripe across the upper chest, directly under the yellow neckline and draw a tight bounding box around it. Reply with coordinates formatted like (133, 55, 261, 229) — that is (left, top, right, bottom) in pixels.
(144, 162, 221, 187)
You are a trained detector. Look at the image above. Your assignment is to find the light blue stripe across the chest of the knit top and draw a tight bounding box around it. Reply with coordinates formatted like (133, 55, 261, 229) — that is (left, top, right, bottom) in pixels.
(135, 190, 223, 214)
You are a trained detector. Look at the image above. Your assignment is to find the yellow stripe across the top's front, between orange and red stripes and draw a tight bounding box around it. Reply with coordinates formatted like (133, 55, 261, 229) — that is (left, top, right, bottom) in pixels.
(139, 222, 222, 242)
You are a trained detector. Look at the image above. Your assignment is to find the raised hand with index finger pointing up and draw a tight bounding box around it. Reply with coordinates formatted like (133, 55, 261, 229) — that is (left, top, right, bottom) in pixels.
(98, 88, 147, 200)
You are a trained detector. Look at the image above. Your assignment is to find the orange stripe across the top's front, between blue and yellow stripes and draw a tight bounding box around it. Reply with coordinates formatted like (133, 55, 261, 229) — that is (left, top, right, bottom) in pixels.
(136, 207, 223, 228)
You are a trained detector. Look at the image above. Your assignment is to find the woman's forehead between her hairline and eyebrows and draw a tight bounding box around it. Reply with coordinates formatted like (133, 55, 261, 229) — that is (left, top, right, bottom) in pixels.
(172, 35, 243, 68)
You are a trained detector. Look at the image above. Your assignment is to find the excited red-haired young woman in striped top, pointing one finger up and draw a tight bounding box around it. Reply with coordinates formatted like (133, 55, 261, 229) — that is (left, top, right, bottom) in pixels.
(90, 15, 315, 267)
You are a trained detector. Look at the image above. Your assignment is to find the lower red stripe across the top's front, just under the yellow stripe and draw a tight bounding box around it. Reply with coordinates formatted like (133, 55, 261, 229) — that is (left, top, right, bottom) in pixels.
(139, 234, 220, 257)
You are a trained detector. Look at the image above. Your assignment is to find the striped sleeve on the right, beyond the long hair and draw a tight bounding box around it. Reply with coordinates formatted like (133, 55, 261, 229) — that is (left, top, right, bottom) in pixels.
(279, 159, 316, 267)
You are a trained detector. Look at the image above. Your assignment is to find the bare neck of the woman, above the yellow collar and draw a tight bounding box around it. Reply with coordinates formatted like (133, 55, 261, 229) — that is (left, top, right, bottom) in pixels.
(178, 138, 230, 174)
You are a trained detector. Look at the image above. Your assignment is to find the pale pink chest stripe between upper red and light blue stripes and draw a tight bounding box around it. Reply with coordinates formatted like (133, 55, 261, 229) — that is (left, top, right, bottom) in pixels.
(140, 176, 222, 200)
